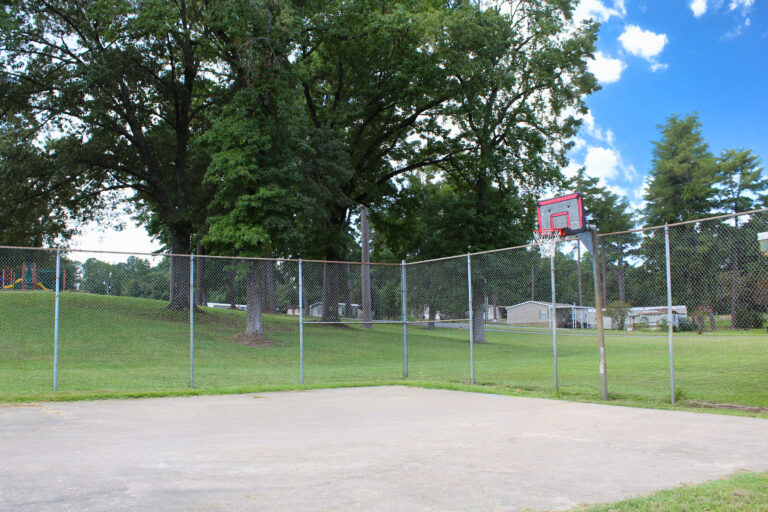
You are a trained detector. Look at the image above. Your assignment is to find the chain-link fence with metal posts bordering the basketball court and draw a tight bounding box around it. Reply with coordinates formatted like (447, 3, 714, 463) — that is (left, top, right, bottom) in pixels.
(0, 211, 768, 407)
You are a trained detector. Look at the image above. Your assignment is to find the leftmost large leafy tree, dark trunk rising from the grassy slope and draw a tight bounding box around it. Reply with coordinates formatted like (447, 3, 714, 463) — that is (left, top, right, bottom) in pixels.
(0, 0, 245, 308)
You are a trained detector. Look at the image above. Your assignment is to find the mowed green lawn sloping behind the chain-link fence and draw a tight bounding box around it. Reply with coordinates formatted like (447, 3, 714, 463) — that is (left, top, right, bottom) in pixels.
(0, 292, 768, 406)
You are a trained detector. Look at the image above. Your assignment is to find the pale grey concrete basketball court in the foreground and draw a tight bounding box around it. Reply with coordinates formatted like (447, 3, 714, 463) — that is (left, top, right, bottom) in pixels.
(0, 386, 768, 512)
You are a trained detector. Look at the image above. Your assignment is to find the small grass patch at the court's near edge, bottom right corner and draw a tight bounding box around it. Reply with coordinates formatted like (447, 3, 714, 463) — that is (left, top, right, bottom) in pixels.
(574, 472, 768, 512)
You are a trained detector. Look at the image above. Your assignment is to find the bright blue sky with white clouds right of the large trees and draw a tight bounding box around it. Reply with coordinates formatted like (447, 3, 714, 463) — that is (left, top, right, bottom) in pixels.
(567, 0, 768, 211)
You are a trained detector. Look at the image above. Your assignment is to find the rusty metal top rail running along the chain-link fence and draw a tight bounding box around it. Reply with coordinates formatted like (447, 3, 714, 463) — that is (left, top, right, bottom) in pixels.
(0, 208, 768, 267)
